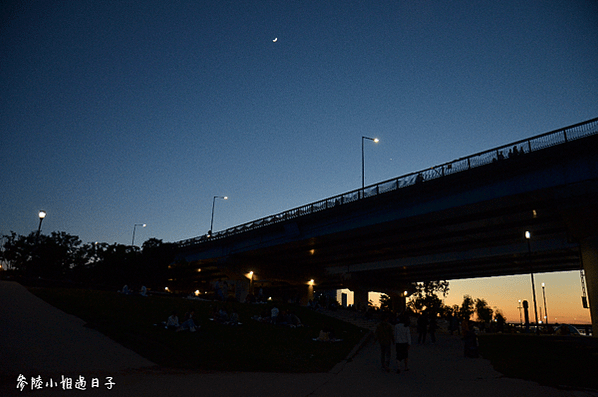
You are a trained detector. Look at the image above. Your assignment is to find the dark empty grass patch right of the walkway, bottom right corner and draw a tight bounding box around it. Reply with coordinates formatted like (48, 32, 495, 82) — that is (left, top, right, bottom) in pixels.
(479, 334, 598, 390)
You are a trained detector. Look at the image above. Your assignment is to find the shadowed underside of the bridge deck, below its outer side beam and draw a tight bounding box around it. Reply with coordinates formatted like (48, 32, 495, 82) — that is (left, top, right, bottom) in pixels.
(216, 186, 580, 290)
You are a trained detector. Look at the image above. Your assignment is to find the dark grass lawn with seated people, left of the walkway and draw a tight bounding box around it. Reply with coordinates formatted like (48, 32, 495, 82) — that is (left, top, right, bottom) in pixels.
(30, 288, 367, 372)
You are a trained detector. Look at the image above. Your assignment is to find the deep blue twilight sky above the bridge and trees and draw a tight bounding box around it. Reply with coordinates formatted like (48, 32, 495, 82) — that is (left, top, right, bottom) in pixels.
(0, 0, 598, 322)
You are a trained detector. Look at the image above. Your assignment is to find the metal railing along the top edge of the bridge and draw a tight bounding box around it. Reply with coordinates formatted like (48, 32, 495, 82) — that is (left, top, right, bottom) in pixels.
(178, 118, 598, 247)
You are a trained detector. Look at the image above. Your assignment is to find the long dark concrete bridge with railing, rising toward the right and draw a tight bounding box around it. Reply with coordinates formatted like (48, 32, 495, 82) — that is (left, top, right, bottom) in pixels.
(173, 118, 598, 335)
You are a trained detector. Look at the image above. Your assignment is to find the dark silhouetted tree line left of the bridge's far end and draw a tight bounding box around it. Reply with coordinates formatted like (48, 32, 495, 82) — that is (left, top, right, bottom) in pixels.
(0, 232, 177, 288)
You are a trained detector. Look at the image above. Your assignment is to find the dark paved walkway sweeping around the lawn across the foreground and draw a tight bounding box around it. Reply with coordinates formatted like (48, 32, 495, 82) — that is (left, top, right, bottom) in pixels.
(0, 282, 598, 397)
